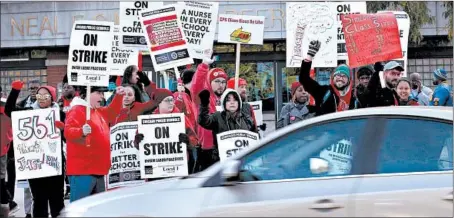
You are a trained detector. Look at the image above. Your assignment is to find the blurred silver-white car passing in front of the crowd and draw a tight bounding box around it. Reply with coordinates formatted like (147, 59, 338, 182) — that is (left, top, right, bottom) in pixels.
(61, 107, 453, 217)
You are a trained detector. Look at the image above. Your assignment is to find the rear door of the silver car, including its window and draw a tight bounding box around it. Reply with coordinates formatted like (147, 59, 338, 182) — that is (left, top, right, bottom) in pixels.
(355, 117, 453, 217)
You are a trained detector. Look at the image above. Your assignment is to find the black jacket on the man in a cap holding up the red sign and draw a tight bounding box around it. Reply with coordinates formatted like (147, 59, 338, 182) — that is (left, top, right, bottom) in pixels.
(364, 71, 399, 107)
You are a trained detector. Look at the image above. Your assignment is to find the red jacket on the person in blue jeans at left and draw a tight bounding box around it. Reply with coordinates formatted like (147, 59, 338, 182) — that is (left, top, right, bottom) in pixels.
(64, 95, 123, 176)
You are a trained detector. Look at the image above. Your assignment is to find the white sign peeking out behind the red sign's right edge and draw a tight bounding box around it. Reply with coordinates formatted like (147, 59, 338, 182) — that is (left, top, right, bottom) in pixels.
(377, 11, 410, 77)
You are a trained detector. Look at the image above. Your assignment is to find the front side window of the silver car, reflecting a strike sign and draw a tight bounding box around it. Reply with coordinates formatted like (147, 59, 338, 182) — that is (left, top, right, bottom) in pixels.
(240, 119, 367, 181)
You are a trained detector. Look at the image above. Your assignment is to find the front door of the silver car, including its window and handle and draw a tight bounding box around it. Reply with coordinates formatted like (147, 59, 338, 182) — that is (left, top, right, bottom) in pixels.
(200, 118, 374, 217)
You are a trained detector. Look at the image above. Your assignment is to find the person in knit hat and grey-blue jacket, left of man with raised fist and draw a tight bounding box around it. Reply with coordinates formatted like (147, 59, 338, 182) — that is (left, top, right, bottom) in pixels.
(277, 81, 317, 129)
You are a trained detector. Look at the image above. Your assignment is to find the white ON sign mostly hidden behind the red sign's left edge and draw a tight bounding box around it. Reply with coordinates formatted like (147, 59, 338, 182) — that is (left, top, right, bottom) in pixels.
(336, 2, 367, 60)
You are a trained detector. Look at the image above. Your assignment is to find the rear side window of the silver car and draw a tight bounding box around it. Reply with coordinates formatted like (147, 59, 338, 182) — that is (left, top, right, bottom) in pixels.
(377, 118, 453, 173)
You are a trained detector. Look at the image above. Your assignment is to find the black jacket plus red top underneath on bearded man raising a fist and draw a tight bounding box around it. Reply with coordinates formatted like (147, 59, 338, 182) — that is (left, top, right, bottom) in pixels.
(299, 60, 356, 116)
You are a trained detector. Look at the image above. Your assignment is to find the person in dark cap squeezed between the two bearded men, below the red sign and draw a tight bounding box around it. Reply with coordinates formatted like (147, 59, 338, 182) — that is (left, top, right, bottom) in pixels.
(354, 65, 374, 108)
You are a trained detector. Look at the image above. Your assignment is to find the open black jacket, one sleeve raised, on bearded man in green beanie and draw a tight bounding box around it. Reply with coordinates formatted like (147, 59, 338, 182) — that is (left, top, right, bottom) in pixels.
(299, 60, 356, 116)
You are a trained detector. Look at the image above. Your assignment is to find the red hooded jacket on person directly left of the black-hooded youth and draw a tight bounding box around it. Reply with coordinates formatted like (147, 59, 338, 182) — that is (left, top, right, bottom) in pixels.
(191, 63, 220, 149)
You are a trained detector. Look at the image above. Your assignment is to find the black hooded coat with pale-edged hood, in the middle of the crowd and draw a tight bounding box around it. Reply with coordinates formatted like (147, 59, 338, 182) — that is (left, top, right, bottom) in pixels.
(199, 89, 257, 148)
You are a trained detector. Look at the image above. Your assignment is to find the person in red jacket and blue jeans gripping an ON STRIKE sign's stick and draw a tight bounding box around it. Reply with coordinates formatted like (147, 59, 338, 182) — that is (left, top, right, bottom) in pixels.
(65, 87, 124, 202)
